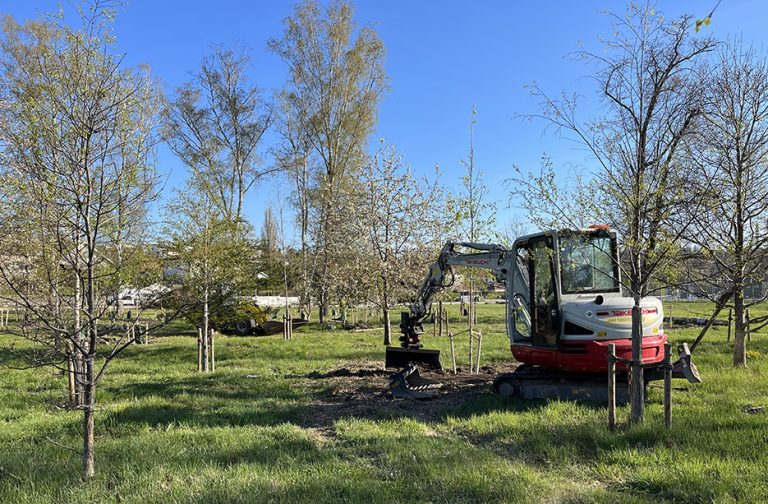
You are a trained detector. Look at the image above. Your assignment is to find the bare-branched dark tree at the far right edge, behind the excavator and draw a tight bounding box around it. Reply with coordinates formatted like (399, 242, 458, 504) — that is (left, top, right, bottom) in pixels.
(683, 41, 768, 366)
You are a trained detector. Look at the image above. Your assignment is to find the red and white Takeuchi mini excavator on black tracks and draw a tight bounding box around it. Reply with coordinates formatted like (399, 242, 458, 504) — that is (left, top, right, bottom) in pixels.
(386, 225, 701, 402)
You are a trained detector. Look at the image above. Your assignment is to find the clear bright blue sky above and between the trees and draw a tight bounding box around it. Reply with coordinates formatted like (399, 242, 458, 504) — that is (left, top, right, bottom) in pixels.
(0, 0, 768, 240)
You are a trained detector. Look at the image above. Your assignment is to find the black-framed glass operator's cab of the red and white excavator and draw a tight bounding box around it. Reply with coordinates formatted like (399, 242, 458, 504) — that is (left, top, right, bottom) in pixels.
(507, 226, 628, 368)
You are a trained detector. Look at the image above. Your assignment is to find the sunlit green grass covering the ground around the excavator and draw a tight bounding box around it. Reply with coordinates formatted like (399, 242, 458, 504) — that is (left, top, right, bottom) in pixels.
(0, 303, 768, 503)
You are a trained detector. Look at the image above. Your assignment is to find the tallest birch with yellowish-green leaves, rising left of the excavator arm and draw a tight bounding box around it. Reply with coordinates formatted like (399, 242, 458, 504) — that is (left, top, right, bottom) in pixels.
(268, 0, 387, 321)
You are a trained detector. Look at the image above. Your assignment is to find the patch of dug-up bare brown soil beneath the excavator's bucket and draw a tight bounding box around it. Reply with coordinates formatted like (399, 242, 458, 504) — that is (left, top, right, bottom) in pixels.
(296, 362, 515, 428)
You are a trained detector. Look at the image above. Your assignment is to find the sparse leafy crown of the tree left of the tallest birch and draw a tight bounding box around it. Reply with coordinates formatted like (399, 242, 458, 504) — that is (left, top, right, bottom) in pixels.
(163, 48, 272, 222)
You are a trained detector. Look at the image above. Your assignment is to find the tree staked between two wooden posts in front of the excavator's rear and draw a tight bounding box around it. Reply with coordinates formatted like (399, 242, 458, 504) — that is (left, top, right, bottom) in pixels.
(514, 4, 715, 422)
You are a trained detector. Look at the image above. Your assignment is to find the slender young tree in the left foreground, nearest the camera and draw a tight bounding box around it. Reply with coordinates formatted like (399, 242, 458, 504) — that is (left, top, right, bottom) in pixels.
(0, 2, 158, 479)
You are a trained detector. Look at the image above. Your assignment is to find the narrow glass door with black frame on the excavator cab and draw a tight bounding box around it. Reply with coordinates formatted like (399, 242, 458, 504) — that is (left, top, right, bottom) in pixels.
(529, 237, 560, 348)
